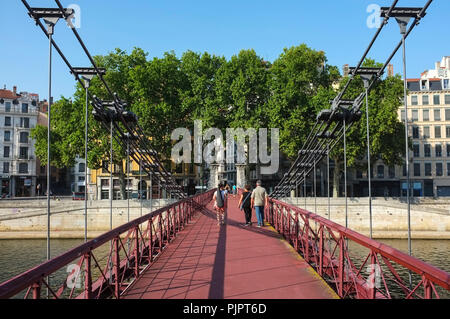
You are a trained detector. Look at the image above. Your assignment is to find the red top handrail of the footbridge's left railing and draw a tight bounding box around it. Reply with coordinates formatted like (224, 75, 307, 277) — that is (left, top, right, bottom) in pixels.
(0, 191, 212, 299)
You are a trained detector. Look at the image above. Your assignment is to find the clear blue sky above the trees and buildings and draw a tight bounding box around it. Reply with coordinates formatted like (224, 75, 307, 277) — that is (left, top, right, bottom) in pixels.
(0, 0, 450, 99)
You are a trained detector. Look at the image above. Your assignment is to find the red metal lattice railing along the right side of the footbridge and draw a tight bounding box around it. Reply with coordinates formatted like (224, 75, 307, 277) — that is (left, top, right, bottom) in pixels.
(265, 199, 450, 299)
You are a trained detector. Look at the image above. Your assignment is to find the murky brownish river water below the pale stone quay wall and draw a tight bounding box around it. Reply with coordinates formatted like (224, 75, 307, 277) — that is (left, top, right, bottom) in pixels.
(0, 240, 450, 299)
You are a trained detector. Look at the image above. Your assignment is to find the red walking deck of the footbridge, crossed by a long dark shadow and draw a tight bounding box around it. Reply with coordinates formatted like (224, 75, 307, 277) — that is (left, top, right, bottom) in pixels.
(122, 196, 338, 299)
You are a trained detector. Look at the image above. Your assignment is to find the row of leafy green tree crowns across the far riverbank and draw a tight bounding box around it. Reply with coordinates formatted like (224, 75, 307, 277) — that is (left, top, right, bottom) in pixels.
(32, 44, 404, 198)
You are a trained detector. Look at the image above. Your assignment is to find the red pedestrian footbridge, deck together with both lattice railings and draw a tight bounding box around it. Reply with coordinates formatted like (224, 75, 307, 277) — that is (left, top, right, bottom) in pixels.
(0, 191, 450, 299)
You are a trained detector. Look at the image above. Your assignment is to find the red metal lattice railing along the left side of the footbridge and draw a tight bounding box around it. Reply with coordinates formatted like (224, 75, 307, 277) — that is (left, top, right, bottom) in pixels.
(0, 191, 213, 299)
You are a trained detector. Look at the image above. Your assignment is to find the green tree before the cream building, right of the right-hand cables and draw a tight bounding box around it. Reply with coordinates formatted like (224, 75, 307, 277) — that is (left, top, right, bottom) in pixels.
(322, 59, 405, 197)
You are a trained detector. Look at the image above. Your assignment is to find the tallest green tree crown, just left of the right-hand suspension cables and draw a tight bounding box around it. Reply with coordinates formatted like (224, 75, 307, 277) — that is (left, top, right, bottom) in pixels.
(264, 44, 339, 159)
